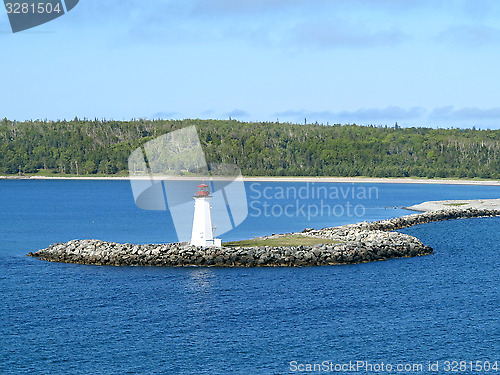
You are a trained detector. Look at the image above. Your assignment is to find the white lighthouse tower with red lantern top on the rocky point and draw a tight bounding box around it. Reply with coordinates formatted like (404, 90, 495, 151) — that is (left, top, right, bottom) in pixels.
(190, 183, 221, 247)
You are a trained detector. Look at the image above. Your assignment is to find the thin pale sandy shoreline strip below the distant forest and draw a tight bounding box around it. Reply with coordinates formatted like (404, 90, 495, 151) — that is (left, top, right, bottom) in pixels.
(0, 176, 500, 186)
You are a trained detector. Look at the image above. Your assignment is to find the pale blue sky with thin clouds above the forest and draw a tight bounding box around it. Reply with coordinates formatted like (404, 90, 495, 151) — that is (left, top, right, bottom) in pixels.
(0, 0, 500, 129)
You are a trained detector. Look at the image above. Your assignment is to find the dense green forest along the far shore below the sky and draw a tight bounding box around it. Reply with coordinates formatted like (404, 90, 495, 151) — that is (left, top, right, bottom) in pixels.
(0, 118, 500, 179)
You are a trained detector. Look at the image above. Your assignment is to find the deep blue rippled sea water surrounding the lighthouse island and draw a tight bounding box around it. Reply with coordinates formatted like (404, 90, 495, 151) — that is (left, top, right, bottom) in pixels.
(0, 180, 500, 374)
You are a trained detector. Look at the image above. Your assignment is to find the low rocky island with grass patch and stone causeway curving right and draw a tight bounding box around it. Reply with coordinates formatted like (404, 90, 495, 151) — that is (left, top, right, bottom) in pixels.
(28, 200, 500, 267)
